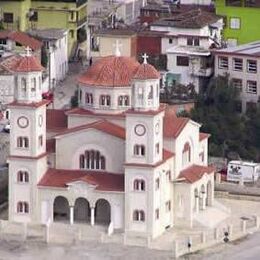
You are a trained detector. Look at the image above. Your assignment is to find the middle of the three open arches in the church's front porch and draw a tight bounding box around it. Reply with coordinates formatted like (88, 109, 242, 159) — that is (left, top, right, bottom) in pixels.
(74, 198, 90, 222)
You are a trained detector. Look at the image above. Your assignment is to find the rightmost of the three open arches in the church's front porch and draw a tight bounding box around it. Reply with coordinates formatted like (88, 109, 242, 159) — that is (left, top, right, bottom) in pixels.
(95, 199, 111, 225)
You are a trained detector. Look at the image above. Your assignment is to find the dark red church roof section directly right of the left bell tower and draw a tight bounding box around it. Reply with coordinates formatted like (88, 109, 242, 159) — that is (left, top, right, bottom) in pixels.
(46, 109, 67, 132)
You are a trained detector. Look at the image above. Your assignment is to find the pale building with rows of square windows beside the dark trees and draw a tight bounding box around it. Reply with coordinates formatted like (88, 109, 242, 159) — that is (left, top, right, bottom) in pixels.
(214, 41, 260, 111)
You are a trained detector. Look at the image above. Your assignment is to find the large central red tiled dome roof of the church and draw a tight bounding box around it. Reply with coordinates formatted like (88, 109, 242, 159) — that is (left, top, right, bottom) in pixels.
(78, 56, 140, 87)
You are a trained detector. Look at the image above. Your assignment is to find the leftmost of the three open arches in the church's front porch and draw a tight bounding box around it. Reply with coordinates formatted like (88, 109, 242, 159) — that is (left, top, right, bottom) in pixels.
(53, 196, 70, 221)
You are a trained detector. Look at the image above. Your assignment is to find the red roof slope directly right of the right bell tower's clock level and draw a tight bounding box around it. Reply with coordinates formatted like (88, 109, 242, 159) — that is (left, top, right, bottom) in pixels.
(163, 110, 189, 138)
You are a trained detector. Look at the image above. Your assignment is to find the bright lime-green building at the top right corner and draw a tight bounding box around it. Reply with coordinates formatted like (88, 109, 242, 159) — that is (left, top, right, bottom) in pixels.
(215, 0, 260, 47)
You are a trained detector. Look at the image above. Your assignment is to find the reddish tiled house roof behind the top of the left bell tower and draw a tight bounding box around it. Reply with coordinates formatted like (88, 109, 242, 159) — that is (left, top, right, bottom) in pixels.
(0, 31, 43, 51)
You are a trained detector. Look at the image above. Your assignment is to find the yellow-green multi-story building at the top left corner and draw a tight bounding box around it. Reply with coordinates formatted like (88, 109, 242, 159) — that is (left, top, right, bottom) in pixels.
(0, 0, 87, 57)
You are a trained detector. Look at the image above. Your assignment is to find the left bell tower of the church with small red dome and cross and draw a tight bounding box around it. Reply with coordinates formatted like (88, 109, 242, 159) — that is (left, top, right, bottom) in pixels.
(8, 47, 47, 222)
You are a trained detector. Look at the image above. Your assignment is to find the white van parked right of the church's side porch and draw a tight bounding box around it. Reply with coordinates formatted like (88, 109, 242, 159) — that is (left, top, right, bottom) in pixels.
(227, 161, 260, 182)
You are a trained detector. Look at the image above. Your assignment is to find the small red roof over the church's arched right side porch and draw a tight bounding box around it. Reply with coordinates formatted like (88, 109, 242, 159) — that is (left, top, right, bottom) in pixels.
(178, 164, 215, 183)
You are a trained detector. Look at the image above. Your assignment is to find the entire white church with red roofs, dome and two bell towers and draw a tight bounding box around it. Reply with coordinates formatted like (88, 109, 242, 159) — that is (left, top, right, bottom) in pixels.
(8, 48, 214, 238)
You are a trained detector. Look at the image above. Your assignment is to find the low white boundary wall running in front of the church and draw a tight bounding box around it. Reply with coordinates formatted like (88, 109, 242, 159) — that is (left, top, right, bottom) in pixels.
(0, 216, 260, 257)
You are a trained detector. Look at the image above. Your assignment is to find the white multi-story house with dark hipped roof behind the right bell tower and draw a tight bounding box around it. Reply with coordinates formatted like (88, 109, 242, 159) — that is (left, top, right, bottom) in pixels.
(151, 9, 223, 92)
